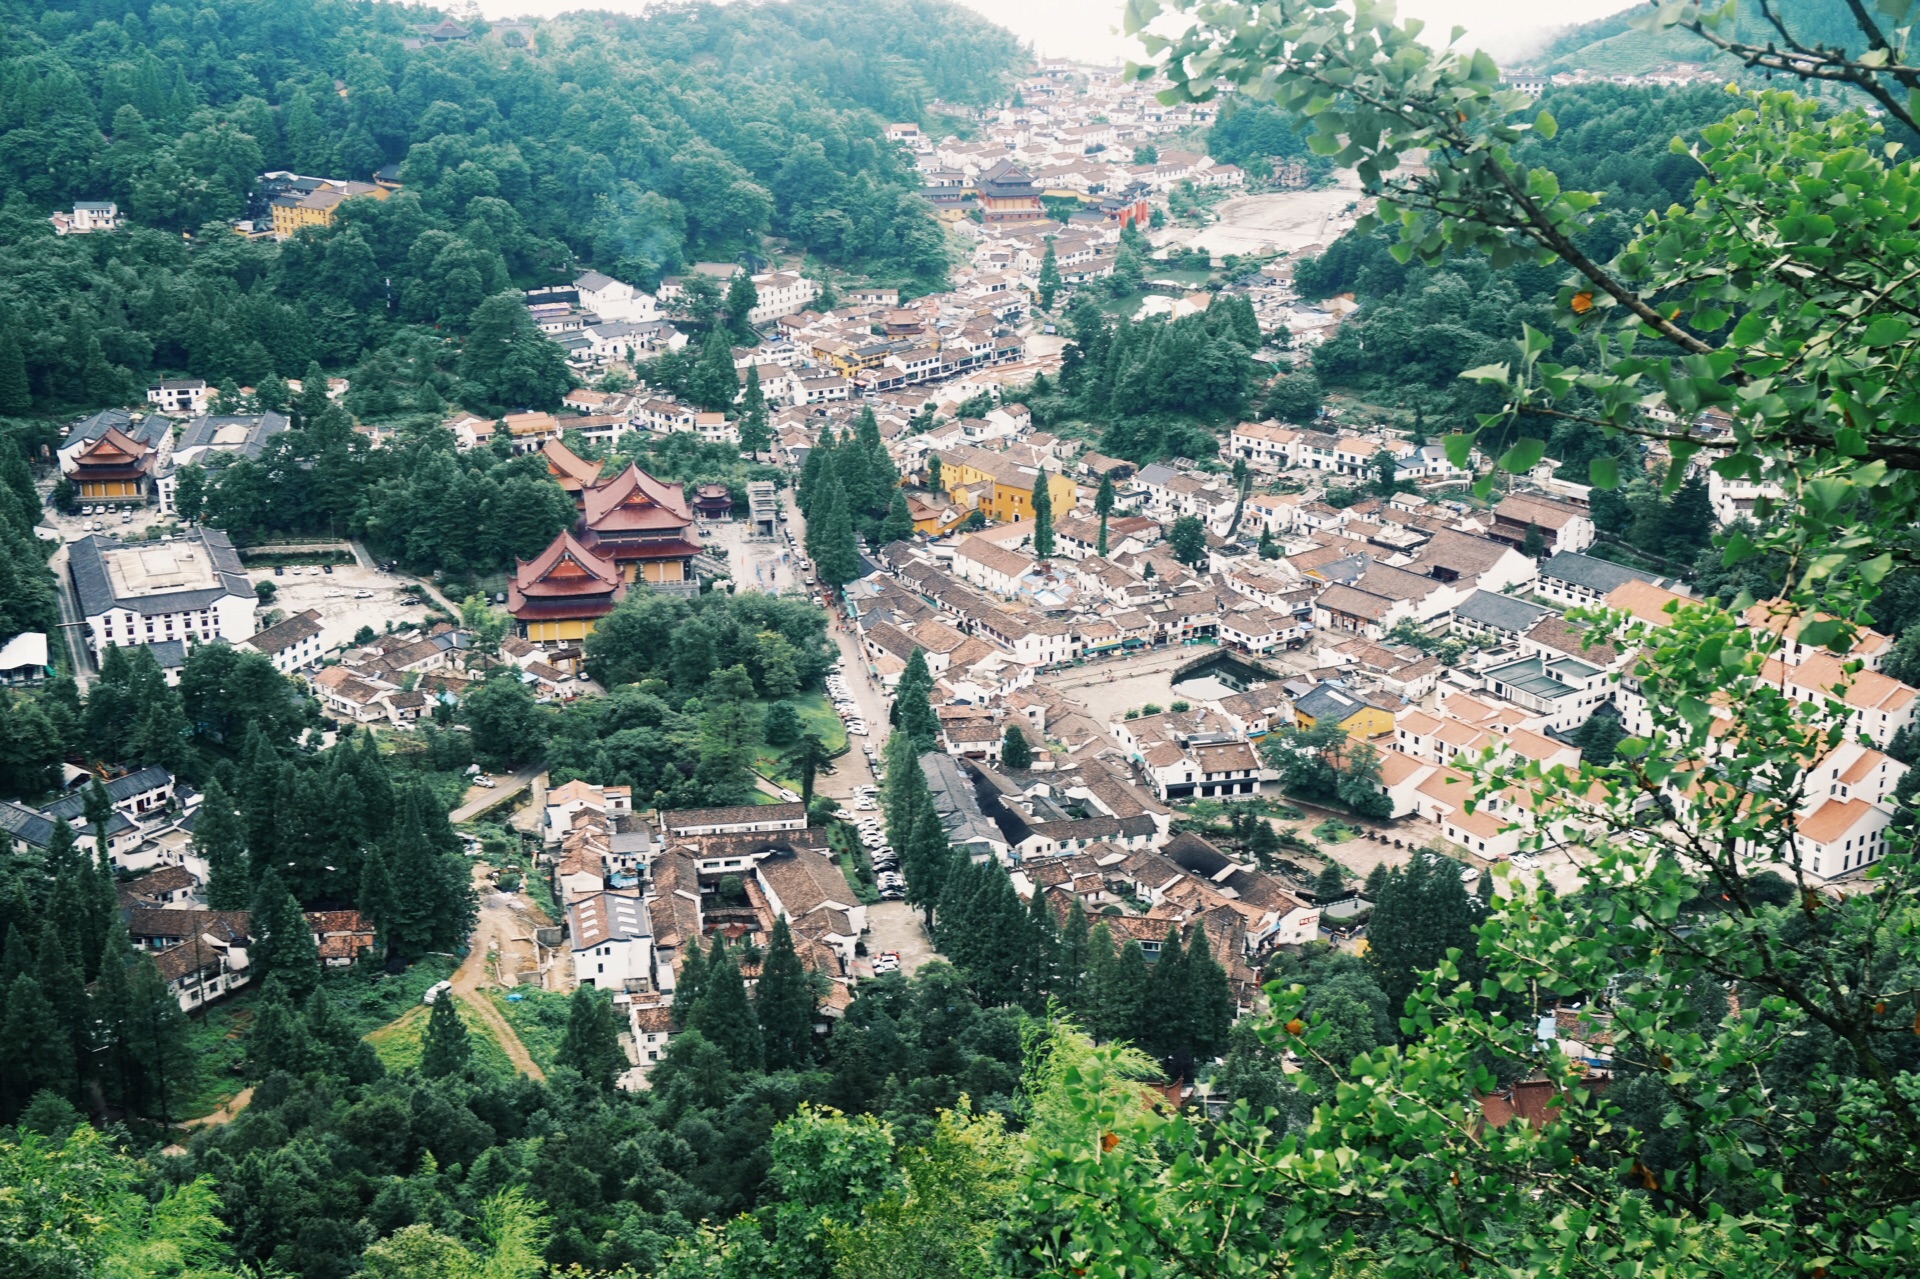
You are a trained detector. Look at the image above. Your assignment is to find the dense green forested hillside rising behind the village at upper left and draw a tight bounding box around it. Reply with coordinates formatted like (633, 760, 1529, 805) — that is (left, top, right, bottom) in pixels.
(0, 0, 1018, 413)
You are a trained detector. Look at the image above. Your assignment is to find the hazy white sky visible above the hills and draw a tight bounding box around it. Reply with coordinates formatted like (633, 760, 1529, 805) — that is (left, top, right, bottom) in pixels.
(480, 0, 1638, 61)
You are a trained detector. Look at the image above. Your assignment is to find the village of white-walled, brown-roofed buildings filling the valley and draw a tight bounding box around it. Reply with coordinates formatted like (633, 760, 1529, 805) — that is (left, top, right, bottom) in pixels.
(0, 47, 1916, 1089)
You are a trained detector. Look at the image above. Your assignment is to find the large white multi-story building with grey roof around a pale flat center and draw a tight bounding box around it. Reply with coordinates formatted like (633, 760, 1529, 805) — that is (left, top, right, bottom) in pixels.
(67, 528, 259, 661)
